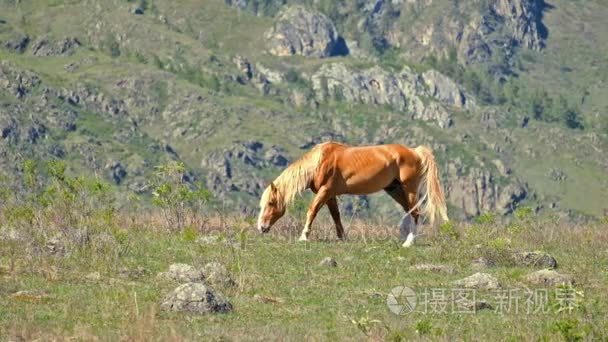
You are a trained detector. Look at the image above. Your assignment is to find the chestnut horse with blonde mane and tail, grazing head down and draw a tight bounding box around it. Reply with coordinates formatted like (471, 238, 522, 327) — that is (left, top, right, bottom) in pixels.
(258, 142, 448, 247)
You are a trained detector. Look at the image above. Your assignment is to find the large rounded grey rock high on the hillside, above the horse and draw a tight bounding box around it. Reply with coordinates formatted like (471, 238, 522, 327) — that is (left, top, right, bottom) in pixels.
(264, 5, 339, 57)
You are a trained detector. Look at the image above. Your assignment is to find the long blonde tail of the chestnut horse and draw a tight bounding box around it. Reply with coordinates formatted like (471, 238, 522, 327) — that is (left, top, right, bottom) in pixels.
(414, 146, 449, 225)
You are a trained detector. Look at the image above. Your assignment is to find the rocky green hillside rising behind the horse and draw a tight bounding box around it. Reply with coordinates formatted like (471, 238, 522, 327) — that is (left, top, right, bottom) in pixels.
(0, 0, 608, 219)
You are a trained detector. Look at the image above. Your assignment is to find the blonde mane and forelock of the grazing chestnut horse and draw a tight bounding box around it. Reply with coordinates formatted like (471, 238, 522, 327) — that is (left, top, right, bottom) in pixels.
(260, 146, 322, 207)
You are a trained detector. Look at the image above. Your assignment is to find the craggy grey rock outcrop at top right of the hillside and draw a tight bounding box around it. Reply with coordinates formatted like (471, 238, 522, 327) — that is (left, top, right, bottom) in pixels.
(385, 0, 546, 64)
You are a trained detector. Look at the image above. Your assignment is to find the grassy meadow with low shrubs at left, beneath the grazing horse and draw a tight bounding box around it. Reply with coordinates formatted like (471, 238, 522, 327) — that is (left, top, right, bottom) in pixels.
(0, 164, 608, 341)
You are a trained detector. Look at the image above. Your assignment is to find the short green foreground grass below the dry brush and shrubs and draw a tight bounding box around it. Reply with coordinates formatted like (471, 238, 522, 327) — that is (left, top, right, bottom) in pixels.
(0, 212, 608, 340)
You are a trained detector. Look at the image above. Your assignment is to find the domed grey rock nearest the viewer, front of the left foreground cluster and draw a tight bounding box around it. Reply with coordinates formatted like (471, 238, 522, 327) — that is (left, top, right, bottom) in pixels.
(160, 283, 232, 314)
